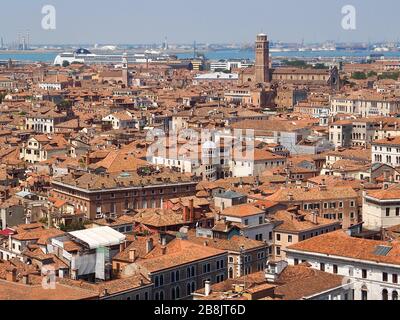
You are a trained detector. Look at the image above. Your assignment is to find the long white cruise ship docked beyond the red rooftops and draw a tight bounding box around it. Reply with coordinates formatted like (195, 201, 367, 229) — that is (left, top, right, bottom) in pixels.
(54, 49, 169, 65)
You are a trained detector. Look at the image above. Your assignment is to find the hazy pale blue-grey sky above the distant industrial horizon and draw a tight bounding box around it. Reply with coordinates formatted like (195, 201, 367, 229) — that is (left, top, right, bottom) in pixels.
(0, 0, 400, 44)
